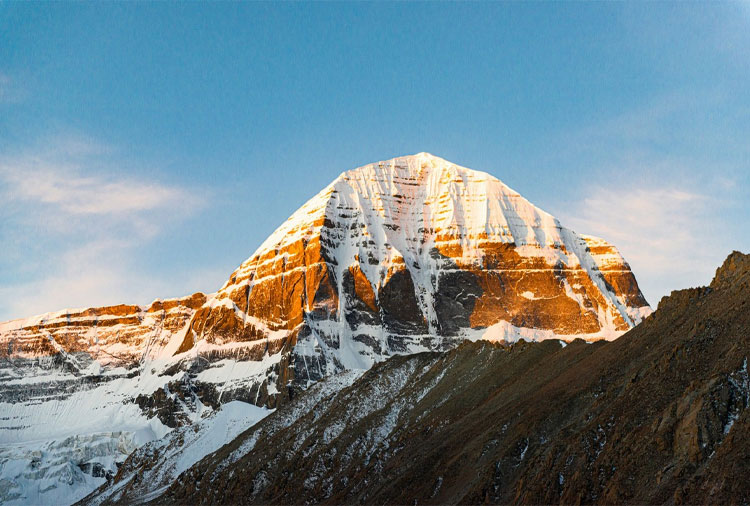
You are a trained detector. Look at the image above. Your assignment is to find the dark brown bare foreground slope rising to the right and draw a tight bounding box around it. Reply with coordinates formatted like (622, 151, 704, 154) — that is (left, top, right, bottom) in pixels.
(122, 252, 750, 504)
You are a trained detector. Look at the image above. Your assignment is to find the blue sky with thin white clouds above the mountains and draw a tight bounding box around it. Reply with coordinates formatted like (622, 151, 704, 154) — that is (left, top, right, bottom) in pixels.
(0, 1, 750, 320)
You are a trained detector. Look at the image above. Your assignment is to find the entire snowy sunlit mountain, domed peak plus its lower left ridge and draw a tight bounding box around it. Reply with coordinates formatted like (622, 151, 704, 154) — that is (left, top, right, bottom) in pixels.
(0, 153, 651, 503)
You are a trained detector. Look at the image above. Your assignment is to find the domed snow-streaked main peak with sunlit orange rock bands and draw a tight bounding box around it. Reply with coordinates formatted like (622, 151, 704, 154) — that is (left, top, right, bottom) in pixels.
(180, 153, 650, 394)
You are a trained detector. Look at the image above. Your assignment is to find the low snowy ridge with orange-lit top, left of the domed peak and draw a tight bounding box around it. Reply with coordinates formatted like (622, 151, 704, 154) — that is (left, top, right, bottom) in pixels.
(0, 294, 276, 504)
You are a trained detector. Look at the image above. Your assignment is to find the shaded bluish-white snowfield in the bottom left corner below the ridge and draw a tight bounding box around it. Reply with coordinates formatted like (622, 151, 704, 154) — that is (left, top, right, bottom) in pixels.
(0, 358, 184, 504)
